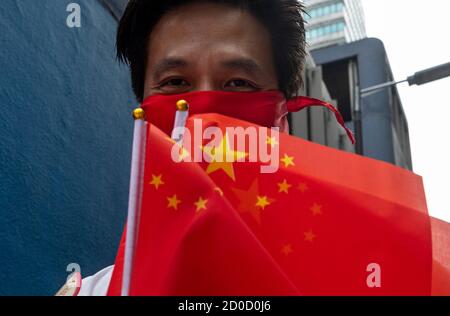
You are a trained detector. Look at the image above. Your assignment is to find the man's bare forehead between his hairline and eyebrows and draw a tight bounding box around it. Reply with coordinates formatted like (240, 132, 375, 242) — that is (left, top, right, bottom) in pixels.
(148, 2, 272, 63)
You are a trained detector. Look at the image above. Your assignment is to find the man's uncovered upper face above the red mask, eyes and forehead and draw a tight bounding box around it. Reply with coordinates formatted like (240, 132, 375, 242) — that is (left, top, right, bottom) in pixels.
(144, 3, 278, 98)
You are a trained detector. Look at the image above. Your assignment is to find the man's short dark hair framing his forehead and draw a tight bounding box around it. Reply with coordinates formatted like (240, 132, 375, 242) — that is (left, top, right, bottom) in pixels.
(116, 0, 306, 102)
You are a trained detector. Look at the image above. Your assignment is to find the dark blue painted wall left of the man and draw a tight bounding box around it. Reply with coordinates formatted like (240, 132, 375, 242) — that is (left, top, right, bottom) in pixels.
(0, 0, 135, 295)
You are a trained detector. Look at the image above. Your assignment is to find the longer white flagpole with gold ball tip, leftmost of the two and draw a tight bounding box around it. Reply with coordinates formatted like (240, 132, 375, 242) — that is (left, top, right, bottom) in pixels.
(121, 108, 147, 296)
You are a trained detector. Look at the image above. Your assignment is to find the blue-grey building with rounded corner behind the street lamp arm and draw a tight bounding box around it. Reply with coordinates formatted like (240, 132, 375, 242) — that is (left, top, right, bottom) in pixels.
(311, 38, 413, 170)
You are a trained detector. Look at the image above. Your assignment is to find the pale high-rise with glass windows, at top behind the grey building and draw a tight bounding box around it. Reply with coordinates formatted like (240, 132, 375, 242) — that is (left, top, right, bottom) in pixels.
(303, 0, 366, 50)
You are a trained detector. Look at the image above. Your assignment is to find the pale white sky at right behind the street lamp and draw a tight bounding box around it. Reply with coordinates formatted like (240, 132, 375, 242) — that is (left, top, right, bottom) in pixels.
(362, 0, 450, 222)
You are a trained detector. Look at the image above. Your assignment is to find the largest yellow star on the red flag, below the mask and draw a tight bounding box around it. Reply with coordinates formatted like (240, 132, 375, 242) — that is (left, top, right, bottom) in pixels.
(203, 134, 248, 181)
